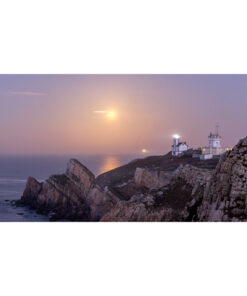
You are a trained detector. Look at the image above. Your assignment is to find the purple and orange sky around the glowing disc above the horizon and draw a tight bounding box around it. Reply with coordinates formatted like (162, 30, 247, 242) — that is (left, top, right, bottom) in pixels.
(0, 75, 247, 155)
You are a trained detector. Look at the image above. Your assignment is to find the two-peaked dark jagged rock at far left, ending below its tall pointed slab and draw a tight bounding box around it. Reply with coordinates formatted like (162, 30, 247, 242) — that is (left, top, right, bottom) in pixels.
(21, 159, 95, 220)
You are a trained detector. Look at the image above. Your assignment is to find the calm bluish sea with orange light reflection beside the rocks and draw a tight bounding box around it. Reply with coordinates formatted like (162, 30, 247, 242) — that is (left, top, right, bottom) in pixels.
(0, 155, 139, 222)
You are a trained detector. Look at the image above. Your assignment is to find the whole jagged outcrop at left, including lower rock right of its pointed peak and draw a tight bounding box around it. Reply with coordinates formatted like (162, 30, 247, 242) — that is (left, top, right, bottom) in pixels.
(21, 159, 121, 221)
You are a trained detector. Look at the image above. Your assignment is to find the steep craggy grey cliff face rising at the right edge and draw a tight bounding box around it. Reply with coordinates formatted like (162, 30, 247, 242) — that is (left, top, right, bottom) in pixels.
(198, 138, 247, 221)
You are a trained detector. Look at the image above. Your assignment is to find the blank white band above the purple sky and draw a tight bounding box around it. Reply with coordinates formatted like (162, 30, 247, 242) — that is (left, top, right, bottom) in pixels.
(0, 0, 247, 74)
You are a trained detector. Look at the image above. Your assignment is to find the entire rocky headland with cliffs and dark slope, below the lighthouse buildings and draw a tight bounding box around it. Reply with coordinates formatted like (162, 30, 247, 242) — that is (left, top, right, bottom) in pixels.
(19, 138, 247, 222)
